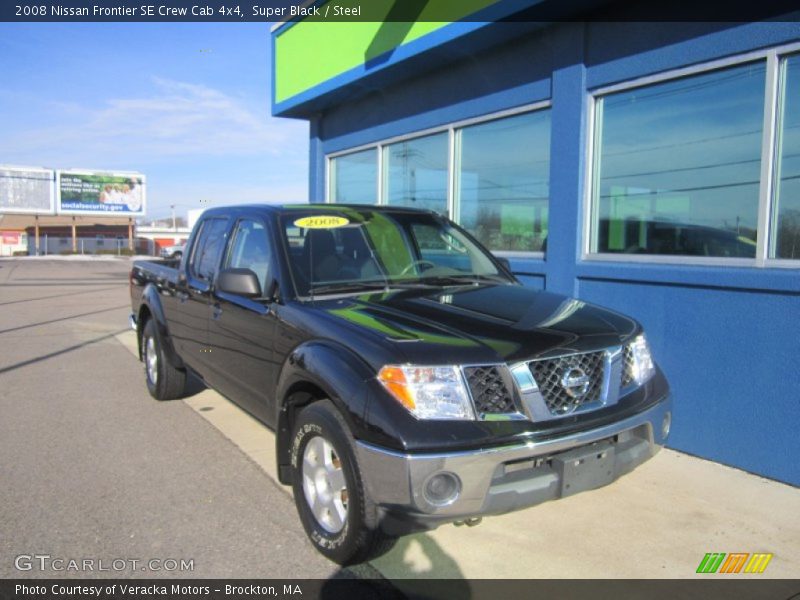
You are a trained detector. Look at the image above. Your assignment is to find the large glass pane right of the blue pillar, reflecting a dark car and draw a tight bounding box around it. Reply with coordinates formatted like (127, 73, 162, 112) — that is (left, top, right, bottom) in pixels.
(593, 62, 765, 257)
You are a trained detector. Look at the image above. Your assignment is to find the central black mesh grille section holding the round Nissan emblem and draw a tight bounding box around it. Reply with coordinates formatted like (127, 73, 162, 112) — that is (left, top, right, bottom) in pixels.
(528, 352, 606, 415)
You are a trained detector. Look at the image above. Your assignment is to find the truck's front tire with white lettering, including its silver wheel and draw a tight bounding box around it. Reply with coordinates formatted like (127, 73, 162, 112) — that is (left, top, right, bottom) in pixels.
(292, 400, 396, 565)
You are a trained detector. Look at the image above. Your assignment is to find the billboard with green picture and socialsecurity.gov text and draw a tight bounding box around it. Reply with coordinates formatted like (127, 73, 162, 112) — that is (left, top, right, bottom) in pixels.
(56, 171, 145, 217)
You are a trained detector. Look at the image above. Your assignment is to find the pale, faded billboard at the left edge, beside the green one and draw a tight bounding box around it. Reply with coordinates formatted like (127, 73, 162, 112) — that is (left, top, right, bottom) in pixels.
(0, 165, 55, 215)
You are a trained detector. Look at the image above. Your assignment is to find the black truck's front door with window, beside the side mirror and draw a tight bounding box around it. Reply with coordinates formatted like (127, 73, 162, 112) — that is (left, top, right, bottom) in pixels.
(208, 217, 278, 424)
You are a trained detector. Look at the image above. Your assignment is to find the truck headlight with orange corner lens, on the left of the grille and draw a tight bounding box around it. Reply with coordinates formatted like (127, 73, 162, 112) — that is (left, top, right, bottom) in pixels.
(378, 365, 475, 420)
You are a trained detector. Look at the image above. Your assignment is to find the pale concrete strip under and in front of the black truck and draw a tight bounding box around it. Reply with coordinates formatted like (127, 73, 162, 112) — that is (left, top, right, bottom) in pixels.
(117, 332, 800, 579)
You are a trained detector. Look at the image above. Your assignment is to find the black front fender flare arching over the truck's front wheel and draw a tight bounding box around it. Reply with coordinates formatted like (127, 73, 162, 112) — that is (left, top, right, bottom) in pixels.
(275, 340, 375, 485)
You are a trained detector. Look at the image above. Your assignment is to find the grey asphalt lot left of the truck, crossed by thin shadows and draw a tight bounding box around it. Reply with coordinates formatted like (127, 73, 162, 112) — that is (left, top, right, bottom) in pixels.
(0, 260, 350, 577)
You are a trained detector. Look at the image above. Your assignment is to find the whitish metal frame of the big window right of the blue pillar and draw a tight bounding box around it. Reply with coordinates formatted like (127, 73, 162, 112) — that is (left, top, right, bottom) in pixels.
(581, 43, 800, 269)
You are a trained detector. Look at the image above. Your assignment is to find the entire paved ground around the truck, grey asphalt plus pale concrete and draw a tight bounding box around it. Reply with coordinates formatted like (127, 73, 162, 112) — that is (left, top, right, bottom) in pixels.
(0, 259, 800, 586)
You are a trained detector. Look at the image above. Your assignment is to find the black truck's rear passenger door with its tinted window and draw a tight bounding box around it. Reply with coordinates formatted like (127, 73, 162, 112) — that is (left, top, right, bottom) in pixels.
(170, 217, 230, 377)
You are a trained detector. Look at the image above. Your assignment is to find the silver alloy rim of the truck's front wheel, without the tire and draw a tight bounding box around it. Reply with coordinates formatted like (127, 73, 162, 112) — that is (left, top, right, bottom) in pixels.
(303, 436, 348, 534)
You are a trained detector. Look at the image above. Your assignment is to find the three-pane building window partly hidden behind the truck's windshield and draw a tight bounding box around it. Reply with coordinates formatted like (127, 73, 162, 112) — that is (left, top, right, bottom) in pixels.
(328, 102, 550, 252)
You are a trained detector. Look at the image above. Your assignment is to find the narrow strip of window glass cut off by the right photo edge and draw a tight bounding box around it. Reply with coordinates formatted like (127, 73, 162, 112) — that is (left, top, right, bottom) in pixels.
(775, 56, 800, 258)
